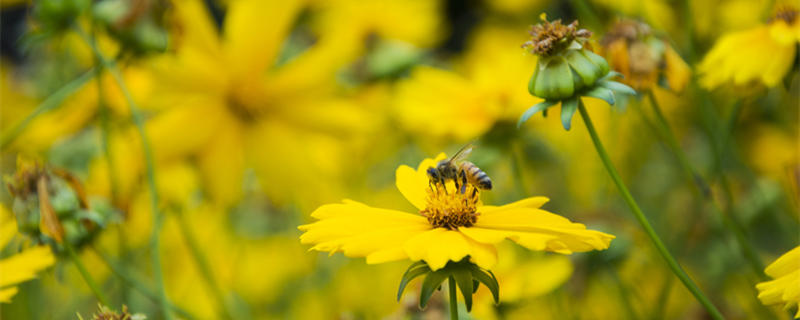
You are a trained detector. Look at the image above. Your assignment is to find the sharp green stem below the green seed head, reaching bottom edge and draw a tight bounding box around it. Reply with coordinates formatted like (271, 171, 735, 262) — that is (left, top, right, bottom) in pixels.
(578, 100, 723, 319)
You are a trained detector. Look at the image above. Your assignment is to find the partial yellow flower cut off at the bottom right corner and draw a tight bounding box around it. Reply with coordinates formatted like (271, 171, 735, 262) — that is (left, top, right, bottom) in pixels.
(756, 246, 800, 318)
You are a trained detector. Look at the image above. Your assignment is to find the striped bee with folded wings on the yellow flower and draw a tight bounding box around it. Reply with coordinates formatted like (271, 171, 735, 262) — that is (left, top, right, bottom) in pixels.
(427, 144, 492, 193)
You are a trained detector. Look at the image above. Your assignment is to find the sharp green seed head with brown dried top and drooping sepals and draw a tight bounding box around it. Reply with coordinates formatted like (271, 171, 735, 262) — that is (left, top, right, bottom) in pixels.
(517, 14, 635, 130)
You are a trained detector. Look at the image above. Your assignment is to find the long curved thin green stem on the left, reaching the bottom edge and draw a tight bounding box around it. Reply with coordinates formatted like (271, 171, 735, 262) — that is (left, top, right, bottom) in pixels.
(74, 25, 172, 320)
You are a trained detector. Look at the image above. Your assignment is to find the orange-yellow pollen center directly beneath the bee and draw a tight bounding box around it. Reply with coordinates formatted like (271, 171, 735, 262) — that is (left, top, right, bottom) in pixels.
(420, 184, 480, 230)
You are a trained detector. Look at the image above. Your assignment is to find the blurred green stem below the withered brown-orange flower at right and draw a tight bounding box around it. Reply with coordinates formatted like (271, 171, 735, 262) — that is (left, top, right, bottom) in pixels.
(647, 91, 765, 280)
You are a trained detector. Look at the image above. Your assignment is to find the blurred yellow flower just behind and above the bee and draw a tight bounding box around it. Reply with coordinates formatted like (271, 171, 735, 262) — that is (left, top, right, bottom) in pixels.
(393, 27, 541, 142)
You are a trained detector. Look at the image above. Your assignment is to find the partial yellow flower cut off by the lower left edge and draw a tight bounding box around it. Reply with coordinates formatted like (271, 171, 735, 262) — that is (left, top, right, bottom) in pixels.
(0, 205, 55, 303)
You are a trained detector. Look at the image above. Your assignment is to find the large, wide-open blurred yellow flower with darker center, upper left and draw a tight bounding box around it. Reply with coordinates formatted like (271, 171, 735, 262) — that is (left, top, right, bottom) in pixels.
(147, 0, 376, 205)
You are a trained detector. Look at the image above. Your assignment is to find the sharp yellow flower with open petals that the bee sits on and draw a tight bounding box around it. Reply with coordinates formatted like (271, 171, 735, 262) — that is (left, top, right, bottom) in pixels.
(298, 153, 614, 271)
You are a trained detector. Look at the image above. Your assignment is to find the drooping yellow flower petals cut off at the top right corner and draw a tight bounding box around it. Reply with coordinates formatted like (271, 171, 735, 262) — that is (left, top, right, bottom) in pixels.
(698, 6, 800, 89)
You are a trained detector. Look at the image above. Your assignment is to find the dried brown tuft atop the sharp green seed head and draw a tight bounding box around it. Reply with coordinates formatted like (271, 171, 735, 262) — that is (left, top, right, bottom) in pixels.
(522, 15, 592, 56)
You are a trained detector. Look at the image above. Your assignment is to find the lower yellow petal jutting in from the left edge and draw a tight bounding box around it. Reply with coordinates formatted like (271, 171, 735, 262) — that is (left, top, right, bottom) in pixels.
(0, 246, 55, 287)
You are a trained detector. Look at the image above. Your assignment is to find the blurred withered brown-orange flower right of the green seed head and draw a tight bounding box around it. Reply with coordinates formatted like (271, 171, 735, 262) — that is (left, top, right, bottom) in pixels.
(601, 20, 691, 92)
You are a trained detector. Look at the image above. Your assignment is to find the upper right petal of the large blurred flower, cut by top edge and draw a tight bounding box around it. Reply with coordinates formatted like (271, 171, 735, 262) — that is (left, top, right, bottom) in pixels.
(224, 0, 302, 78)
